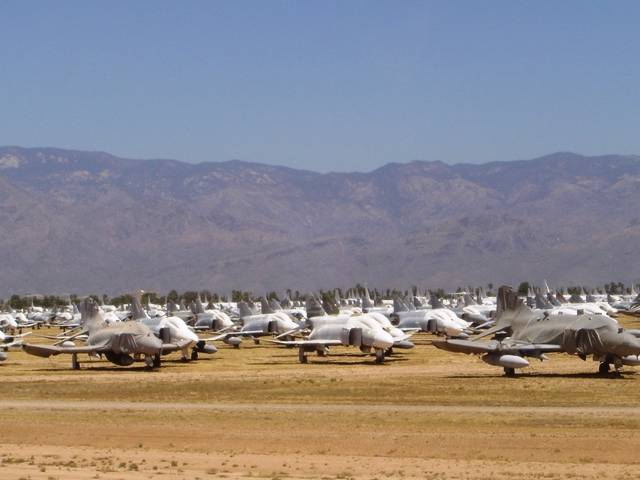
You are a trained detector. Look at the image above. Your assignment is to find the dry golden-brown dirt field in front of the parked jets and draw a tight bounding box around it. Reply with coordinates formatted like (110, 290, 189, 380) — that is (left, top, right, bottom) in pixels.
(0, 318, 640, 480)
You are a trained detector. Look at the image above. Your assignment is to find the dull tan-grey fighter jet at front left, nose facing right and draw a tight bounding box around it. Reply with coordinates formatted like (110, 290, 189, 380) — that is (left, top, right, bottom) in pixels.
(22, 299, 190, 370)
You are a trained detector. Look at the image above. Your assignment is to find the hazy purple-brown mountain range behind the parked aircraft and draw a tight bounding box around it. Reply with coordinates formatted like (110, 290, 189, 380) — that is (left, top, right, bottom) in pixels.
(0, 147, 640, 296)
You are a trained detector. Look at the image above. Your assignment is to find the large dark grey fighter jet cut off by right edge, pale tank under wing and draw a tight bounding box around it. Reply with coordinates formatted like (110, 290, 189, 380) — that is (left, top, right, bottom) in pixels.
(433, 287, 640, 376)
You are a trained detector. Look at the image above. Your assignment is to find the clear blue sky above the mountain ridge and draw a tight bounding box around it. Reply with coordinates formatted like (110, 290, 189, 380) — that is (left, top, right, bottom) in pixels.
(0, 0, 640, 171)
